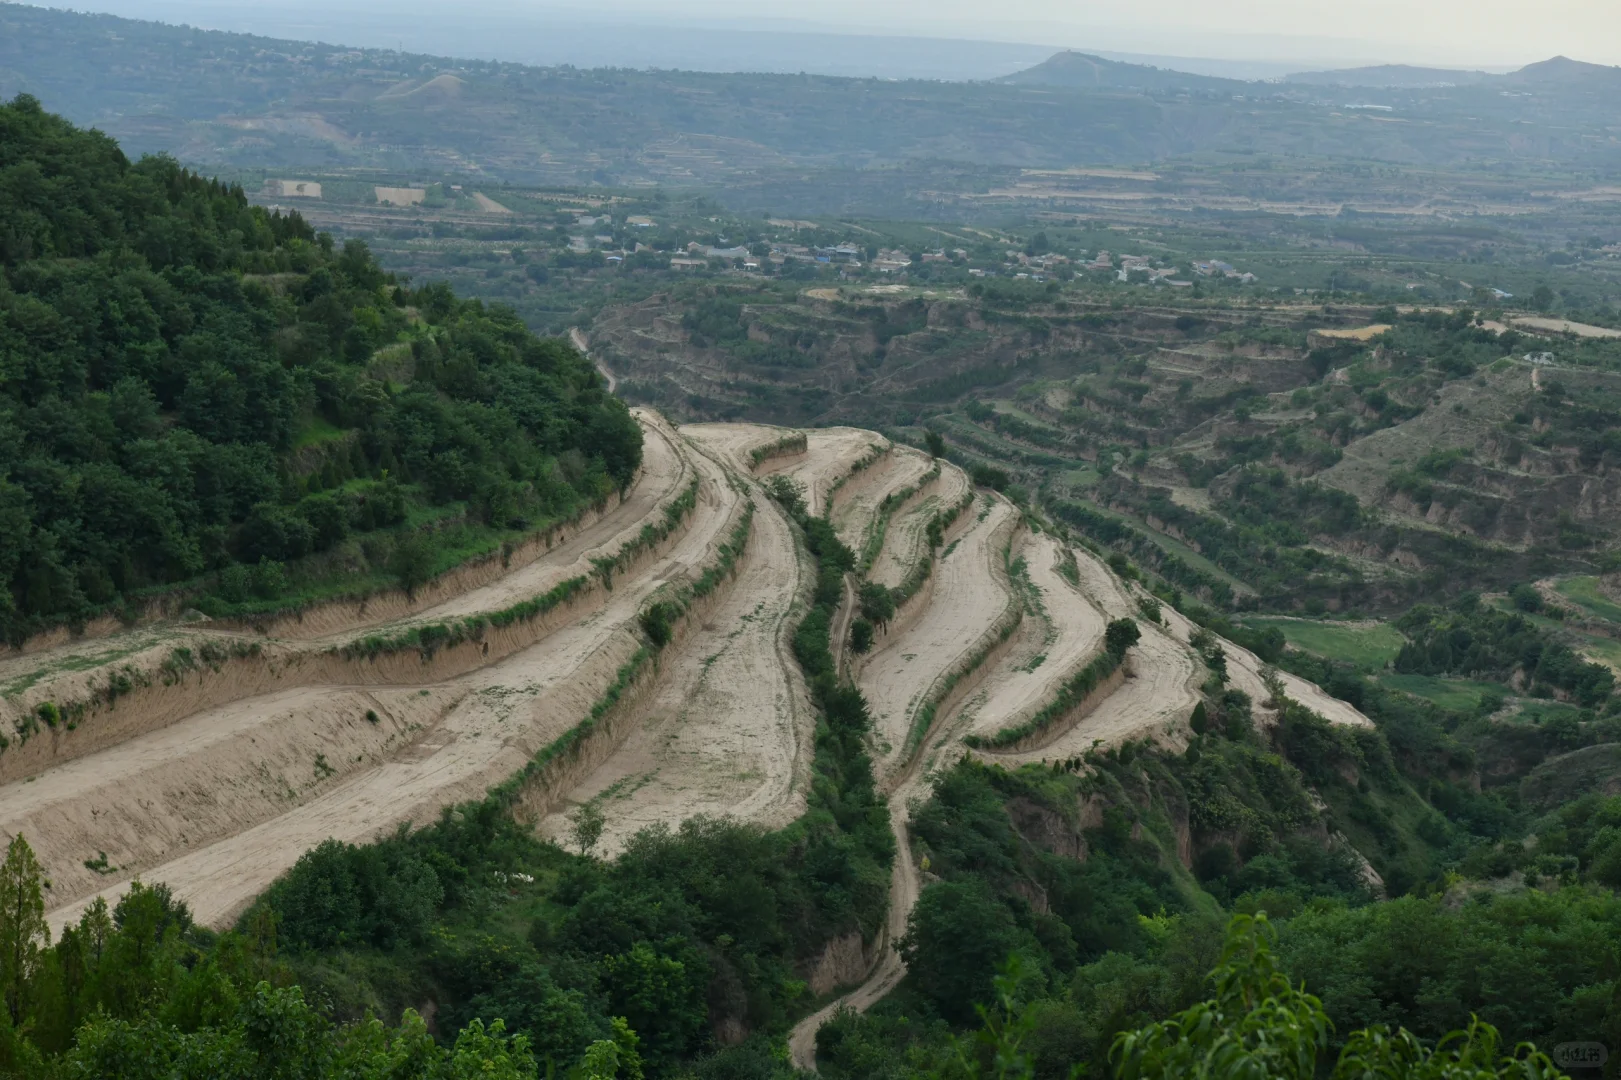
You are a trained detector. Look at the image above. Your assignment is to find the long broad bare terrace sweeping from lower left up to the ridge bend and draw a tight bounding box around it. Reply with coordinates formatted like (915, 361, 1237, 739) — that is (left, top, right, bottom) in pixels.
(38, 441, 741, 926)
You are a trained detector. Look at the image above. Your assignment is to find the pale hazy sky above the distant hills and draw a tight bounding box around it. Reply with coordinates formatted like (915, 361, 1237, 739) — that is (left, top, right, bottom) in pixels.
(79, 0, 1621, 68)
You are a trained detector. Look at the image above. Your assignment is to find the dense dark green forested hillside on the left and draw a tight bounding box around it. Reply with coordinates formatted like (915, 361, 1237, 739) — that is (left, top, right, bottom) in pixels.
(0, 97, 640, 642)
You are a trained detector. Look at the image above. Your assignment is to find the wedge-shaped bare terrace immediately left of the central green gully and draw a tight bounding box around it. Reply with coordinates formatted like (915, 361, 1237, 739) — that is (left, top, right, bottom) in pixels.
(541, 428, 815, 858)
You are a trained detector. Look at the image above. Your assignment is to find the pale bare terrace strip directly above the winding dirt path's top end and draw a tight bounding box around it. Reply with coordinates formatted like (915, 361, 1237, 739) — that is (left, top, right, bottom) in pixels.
(856, 499, 1018, 775)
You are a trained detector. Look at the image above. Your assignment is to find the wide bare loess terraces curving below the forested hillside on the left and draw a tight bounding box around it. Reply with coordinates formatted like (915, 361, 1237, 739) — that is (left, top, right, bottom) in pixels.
(0, 408, 744, 923)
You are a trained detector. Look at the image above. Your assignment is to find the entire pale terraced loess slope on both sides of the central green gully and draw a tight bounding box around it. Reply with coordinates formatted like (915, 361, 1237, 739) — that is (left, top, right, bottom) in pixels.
(0, 414, 1365, 1065)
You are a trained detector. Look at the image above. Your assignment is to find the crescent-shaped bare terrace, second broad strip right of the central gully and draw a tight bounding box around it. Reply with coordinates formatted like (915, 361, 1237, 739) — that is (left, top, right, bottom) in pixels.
(953, 534, 1107, 749)
